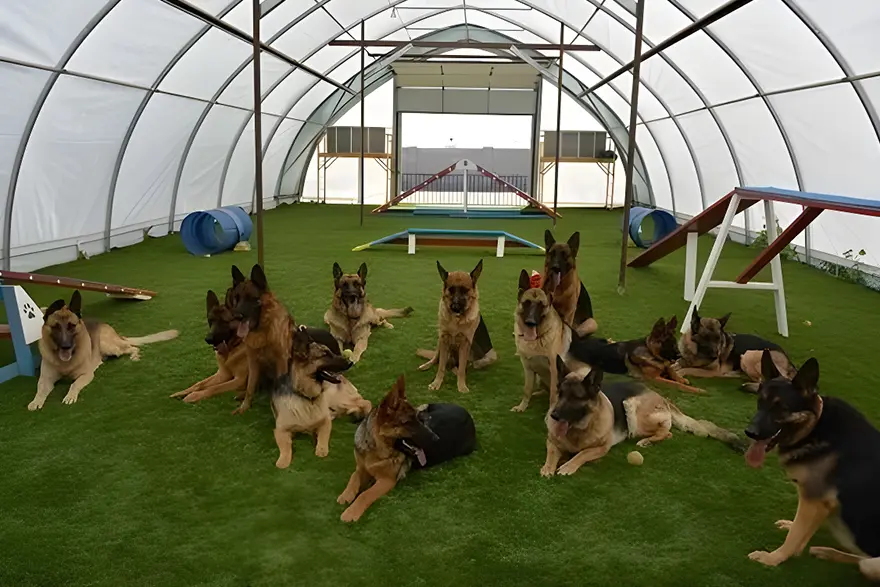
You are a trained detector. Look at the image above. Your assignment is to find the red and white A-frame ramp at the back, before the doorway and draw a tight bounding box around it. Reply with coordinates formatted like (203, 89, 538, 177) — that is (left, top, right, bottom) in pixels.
(373, 159, 560, 218)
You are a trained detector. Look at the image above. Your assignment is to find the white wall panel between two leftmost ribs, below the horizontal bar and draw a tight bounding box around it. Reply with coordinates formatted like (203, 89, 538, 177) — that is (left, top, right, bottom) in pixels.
(12, 76, 145, 247)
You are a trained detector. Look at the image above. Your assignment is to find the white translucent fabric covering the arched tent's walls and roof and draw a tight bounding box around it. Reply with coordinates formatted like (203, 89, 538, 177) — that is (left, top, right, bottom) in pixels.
(0, 0, 880, 269)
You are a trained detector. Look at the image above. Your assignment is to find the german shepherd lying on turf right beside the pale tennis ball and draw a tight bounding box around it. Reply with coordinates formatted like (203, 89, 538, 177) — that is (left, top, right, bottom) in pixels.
(541, 357, 741, 477)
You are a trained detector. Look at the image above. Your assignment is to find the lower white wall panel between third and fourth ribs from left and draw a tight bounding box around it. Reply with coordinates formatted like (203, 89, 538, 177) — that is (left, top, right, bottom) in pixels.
(175, 105, 248, 215)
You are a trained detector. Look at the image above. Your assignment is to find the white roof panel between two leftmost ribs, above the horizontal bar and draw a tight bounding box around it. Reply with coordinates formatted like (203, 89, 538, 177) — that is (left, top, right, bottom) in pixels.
(68, 0, 204, 86)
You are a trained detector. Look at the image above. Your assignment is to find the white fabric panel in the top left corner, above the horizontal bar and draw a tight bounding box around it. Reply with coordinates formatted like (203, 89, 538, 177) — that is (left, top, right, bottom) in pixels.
(0, 0, 108, 66)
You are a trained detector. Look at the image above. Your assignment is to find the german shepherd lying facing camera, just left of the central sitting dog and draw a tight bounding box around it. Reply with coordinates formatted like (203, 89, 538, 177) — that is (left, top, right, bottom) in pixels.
(324, 263, 413, 363)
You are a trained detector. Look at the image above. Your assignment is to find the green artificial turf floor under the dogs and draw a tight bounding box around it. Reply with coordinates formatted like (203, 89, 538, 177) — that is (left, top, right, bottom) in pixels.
(0, 204, 880, 587)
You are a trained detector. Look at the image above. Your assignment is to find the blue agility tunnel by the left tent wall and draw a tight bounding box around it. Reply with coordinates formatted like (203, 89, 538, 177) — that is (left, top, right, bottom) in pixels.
(180, 206, 254, 256)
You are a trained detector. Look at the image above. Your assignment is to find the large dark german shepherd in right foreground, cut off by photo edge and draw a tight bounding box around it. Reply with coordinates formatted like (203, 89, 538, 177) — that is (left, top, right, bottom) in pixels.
(745, 350, 880, 581)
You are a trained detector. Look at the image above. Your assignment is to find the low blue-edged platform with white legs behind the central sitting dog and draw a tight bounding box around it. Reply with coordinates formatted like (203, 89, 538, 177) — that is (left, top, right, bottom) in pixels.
(352, 228, 544, 257)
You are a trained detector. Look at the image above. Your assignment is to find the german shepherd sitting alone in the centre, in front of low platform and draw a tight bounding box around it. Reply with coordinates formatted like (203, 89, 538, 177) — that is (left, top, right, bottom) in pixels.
(416, 259, 498, 393)
